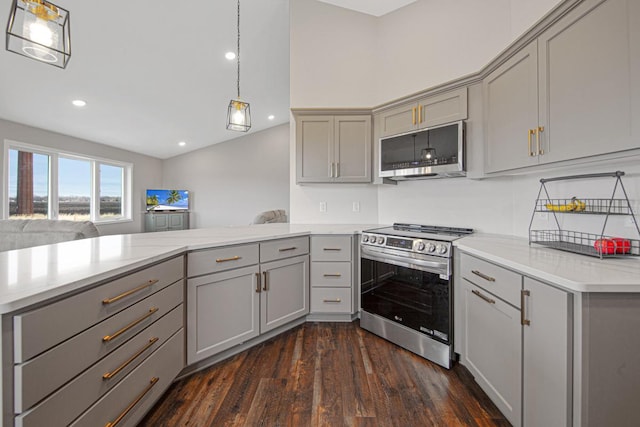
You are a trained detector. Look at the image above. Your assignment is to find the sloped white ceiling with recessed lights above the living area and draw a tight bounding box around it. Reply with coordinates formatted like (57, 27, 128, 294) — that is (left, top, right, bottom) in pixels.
(0, 0, 295, 159)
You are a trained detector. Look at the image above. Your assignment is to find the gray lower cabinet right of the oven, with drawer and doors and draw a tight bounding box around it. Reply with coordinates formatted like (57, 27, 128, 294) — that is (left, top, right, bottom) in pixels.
(455, 253, 573, 427)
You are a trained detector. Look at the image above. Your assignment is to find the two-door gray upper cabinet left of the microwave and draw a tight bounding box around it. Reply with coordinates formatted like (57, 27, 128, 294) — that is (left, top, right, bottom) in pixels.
(296, 115, 371, 183)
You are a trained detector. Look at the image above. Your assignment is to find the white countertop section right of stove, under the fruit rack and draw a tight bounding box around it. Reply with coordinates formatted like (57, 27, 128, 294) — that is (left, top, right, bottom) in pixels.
(454, 234, 640, 292)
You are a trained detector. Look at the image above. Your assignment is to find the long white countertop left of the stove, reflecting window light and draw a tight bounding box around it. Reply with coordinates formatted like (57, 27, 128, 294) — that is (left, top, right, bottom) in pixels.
(0, 224, 381, 314)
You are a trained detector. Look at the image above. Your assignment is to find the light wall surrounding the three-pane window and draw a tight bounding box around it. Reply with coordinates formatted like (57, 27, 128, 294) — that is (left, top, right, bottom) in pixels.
(0, 119, 162, 235)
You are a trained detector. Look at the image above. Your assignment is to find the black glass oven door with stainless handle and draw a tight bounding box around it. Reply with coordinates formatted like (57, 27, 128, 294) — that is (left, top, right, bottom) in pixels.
(361, 246, 451, 344)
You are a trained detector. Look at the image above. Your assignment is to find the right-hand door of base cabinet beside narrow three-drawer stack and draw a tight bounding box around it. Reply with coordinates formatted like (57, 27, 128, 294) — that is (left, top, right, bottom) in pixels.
(260, 255, 309, 333)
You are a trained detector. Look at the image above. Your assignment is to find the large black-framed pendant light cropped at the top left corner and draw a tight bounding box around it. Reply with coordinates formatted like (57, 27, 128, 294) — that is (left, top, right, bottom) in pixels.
(6, 0, 71, 68)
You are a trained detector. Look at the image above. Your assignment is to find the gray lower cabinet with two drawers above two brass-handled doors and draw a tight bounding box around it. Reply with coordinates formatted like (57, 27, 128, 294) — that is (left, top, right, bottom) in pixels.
(187, 236, 309, 364)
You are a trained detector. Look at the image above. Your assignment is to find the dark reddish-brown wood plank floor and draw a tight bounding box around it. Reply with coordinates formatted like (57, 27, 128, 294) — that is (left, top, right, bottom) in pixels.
(140, 322, 510, 427)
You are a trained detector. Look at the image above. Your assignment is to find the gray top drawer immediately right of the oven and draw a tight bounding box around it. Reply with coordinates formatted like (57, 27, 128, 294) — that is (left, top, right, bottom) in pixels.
(460, 253, 522, 307)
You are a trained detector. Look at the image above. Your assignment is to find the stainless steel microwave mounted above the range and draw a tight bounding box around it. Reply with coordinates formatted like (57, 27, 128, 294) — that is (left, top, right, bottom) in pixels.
(378, 120, 466, 180)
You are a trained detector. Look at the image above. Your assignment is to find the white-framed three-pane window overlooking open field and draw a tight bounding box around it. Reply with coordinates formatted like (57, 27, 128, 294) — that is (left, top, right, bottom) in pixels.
(4, 141, 133, 223)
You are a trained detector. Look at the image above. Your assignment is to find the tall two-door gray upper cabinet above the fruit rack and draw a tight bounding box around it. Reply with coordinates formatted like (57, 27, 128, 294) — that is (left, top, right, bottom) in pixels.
(483, 0, 640, 173)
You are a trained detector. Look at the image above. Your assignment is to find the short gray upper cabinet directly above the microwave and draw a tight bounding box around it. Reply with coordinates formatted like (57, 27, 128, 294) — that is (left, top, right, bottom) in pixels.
(376, 87, 467, 137)
